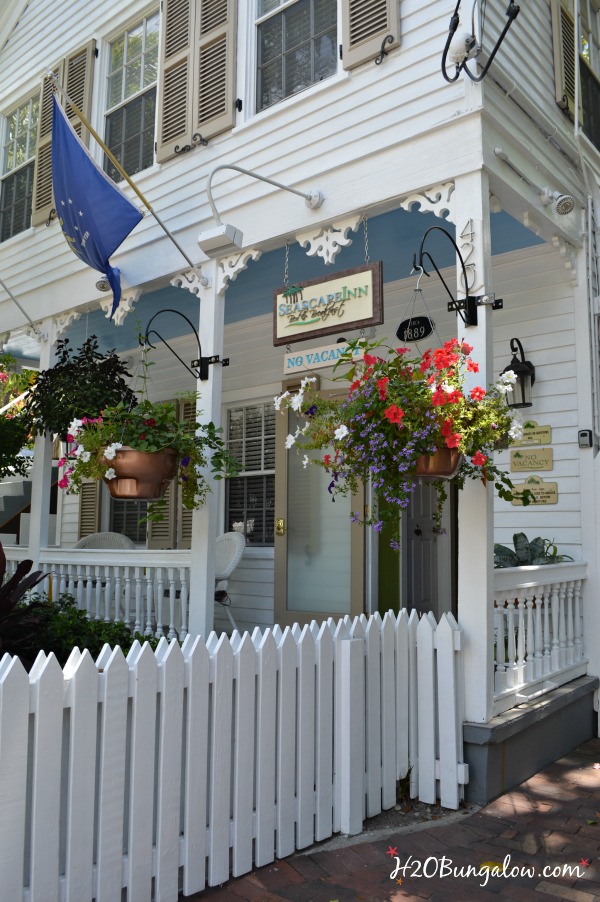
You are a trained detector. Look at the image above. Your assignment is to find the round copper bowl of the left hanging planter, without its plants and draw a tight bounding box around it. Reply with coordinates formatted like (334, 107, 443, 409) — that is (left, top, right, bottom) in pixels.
(104, 445, 178, 501)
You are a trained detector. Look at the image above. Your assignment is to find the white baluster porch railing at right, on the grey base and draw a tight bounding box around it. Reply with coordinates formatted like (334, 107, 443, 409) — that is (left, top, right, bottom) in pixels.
(494, 562, 587, 714)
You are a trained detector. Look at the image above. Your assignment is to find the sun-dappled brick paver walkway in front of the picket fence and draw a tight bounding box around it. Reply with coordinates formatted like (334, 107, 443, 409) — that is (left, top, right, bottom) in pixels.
(182, 739, 600, 902)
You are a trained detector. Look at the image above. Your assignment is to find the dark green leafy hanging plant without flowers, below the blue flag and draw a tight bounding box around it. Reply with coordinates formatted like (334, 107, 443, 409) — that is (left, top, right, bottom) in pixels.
(25, 335, 135, 439)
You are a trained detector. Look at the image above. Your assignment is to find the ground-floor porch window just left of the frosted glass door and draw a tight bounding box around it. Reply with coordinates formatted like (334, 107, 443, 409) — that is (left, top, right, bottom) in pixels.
(225, 402, 275, 545)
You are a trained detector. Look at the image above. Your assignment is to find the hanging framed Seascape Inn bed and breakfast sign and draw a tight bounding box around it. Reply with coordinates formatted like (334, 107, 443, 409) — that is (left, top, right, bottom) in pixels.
(273, 261, 383, 347)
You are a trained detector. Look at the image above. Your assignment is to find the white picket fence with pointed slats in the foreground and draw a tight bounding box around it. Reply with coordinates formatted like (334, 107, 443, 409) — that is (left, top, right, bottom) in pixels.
(0, 611, 467, 902)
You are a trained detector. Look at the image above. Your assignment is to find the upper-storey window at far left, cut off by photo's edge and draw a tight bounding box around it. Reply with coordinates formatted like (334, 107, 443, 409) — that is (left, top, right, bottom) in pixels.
(0, 96, 39, 241)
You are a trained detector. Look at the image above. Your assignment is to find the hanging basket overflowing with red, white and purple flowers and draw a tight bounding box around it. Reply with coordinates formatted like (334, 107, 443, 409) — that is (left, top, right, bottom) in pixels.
(275, 339, 530, 549)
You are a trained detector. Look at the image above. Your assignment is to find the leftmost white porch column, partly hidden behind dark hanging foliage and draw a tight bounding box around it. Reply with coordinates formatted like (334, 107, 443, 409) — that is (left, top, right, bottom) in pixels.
(29, 317, 56, 570)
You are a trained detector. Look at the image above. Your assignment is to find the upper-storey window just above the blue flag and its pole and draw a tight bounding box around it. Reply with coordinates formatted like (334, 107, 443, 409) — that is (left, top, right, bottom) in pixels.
(104, 12, 159, 181)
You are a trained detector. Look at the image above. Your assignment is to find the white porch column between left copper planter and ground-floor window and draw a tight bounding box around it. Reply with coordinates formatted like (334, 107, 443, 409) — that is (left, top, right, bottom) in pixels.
(189, 260, 225, 638)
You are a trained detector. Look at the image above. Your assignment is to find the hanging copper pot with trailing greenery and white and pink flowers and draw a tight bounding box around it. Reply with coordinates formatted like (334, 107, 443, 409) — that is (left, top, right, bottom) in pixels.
(58, 399, 237, 519)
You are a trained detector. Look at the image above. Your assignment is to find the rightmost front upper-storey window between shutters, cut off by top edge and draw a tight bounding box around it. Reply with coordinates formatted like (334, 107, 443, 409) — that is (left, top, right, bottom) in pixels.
(256, 0, 338, 111)
